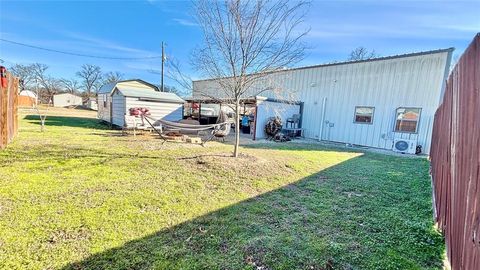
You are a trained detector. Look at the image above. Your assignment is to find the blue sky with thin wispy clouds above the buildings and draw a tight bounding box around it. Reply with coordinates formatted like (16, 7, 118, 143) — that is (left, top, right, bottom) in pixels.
(0, 0, 480, 86)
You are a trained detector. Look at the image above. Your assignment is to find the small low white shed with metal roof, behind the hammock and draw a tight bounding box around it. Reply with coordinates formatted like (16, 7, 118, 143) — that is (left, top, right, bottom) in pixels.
(111, 86, 185, 127)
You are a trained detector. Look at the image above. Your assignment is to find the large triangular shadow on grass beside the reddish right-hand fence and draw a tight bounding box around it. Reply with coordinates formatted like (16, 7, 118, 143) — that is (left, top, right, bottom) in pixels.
(64, 154, 444, 269)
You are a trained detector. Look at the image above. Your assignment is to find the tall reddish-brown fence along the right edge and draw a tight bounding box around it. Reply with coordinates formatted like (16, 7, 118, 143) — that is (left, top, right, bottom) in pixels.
(430, 33, 480, 270)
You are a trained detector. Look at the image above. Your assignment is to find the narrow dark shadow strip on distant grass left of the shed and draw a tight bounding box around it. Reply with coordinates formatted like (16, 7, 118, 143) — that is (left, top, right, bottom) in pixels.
(24, 115, 110, 129)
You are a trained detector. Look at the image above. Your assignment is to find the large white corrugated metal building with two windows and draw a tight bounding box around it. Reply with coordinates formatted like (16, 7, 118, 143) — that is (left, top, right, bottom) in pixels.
(193, 48, 453, 152)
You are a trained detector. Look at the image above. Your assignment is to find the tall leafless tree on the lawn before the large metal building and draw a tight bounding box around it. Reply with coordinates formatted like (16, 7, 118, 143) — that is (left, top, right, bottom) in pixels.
(193, 0, 309, 157)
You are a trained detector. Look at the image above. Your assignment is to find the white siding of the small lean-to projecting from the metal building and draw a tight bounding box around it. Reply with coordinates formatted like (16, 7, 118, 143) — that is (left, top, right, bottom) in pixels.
(255, 101, 300, 139)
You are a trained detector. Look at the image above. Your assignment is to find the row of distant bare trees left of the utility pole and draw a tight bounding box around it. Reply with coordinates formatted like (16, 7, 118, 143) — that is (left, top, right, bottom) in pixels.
(9, 63, 124, 103)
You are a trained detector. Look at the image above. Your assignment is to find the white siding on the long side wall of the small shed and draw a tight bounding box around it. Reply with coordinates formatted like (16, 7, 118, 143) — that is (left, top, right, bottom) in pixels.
(125, 97, 183, 127)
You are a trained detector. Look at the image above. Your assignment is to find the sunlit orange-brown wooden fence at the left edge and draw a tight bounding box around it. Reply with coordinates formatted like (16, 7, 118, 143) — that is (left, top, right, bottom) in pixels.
(0, 72, 18, 149)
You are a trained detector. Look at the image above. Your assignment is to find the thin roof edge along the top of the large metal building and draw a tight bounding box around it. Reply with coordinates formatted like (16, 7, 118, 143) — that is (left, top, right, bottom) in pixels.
(193, 47, 455, 82)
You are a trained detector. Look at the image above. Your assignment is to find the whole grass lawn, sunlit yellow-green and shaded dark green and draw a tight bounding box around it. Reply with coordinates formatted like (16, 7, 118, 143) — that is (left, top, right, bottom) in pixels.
(0, 108, 444, 269)
